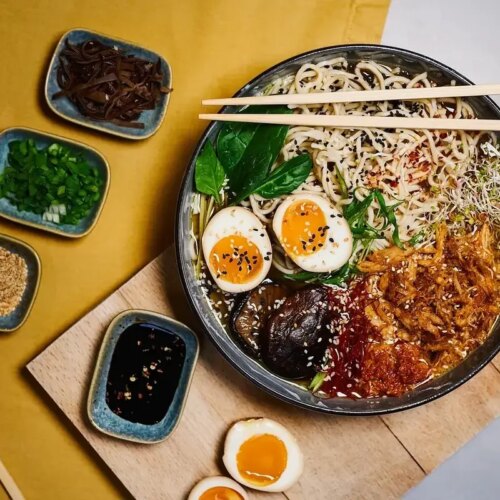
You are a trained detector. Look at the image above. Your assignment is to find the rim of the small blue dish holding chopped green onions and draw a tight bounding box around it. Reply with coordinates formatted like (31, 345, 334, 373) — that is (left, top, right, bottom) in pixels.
(0, 126, 111, 239)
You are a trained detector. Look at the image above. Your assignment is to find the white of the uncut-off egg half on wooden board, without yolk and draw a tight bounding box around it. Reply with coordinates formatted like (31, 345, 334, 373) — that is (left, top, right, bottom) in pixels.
(222, 418, 304, 492)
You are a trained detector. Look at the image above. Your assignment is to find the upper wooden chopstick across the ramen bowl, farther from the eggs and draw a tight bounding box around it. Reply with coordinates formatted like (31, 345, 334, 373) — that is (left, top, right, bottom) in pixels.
(201, 83, 500, 106)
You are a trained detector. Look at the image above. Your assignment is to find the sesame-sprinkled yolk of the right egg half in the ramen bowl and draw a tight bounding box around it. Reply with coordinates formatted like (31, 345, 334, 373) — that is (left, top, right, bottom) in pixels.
(281, 200, 329, 256)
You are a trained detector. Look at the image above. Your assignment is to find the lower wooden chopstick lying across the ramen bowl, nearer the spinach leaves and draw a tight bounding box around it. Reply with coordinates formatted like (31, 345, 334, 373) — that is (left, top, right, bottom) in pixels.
(199, 113, 500, 131)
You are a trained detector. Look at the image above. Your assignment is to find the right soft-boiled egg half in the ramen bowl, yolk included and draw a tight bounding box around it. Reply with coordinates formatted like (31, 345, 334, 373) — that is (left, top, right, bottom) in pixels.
(273, 193, 352, 273)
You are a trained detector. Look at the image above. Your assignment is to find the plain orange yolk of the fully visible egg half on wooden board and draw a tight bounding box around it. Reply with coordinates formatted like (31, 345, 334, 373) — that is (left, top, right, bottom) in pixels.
(236, 434, 287, 486)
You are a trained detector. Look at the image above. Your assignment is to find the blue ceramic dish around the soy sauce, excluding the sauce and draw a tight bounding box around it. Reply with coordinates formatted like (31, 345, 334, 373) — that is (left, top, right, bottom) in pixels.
(87, 310, 199, 444)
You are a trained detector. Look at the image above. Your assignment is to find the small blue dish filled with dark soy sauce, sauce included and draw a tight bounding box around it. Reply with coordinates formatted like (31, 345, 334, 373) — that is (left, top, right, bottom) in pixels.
(87, 310, 198, 444)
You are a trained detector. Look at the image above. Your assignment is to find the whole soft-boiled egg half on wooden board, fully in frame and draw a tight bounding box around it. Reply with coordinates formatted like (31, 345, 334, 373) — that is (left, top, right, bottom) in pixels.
(222, 418, 304, 492)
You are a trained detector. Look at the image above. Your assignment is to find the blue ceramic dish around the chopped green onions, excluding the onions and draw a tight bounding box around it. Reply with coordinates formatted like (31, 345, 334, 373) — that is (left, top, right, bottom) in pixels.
(0, 127, 110, 238)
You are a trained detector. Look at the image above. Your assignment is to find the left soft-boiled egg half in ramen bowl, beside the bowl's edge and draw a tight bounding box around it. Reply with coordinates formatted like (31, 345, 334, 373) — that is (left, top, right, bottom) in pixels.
(202, 207, 273, 293)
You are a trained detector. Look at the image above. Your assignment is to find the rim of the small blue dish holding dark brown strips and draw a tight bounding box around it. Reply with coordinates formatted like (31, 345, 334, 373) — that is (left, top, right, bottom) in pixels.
(43, 27, 173, 141)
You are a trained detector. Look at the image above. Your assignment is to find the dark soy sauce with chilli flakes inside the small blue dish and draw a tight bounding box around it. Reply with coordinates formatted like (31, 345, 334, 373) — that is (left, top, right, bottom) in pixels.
(106, 323, 186, 425)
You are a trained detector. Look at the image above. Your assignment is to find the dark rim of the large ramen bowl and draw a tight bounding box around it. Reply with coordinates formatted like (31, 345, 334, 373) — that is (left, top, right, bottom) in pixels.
(175, 43, 500, 417)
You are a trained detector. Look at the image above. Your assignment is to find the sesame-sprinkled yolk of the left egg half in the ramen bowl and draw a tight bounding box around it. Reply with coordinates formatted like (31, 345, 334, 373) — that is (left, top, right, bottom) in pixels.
(210, 234, 271, 283)
